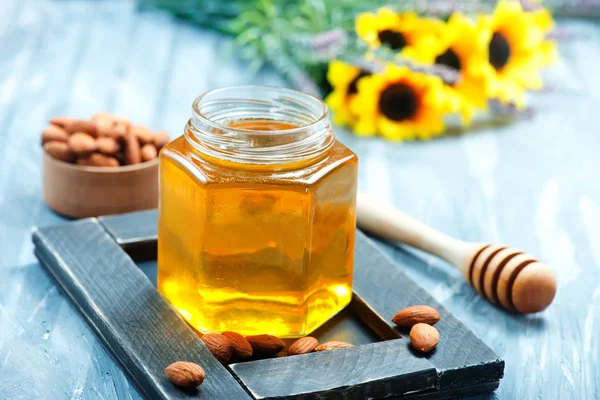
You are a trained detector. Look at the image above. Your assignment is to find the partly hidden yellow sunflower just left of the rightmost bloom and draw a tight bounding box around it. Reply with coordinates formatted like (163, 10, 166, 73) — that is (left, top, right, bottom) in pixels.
(406, 13, 487, 125)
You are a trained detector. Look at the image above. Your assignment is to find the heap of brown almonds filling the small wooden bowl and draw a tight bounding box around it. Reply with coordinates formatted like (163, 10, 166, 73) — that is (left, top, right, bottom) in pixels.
(42, 112, 169, 167)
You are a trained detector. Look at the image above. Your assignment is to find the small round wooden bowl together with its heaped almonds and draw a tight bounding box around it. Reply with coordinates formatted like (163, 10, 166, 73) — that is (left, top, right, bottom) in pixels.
(42, 112, 169, 218)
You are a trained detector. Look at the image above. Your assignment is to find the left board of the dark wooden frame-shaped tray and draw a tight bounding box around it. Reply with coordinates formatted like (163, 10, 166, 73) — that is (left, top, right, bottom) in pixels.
(33, 219, 249, 399)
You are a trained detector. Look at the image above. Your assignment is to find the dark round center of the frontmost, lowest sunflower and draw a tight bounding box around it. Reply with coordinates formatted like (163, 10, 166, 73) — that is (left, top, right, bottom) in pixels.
(379, 83, 419, 121)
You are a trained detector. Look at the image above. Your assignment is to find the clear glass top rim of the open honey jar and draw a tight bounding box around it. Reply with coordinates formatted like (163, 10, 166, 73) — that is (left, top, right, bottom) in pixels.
(192, 85, 329, 134)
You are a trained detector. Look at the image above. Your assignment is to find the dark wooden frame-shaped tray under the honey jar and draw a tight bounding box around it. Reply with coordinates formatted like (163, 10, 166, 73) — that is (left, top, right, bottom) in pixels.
(33, 211, 504, 400)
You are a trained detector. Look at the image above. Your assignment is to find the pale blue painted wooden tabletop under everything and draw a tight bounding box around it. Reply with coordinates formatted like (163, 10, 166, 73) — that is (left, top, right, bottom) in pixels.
(0, 0, 600, 399)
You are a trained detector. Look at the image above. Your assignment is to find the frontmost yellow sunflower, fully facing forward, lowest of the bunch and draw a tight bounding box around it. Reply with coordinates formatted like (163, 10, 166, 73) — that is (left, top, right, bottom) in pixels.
(350, 64, 451, 140)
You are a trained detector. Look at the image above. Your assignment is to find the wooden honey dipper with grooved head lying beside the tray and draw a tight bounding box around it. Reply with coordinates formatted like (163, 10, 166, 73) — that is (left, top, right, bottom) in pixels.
(356, 193, 556, 313)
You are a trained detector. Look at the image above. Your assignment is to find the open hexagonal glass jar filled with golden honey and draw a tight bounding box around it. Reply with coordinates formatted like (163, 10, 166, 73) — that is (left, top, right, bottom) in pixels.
(158, 86, 358, 337)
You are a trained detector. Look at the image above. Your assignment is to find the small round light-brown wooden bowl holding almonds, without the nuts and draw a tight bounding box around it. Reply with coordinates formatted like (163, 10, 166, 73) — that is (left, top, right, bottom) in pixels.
(43, 152, 158, 218)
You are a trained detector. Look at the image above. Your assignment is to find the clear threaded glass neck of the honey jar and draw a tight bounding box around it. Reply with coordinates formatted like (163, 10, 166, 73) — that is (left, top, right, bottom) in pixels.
(185, 86, 335, 170)
